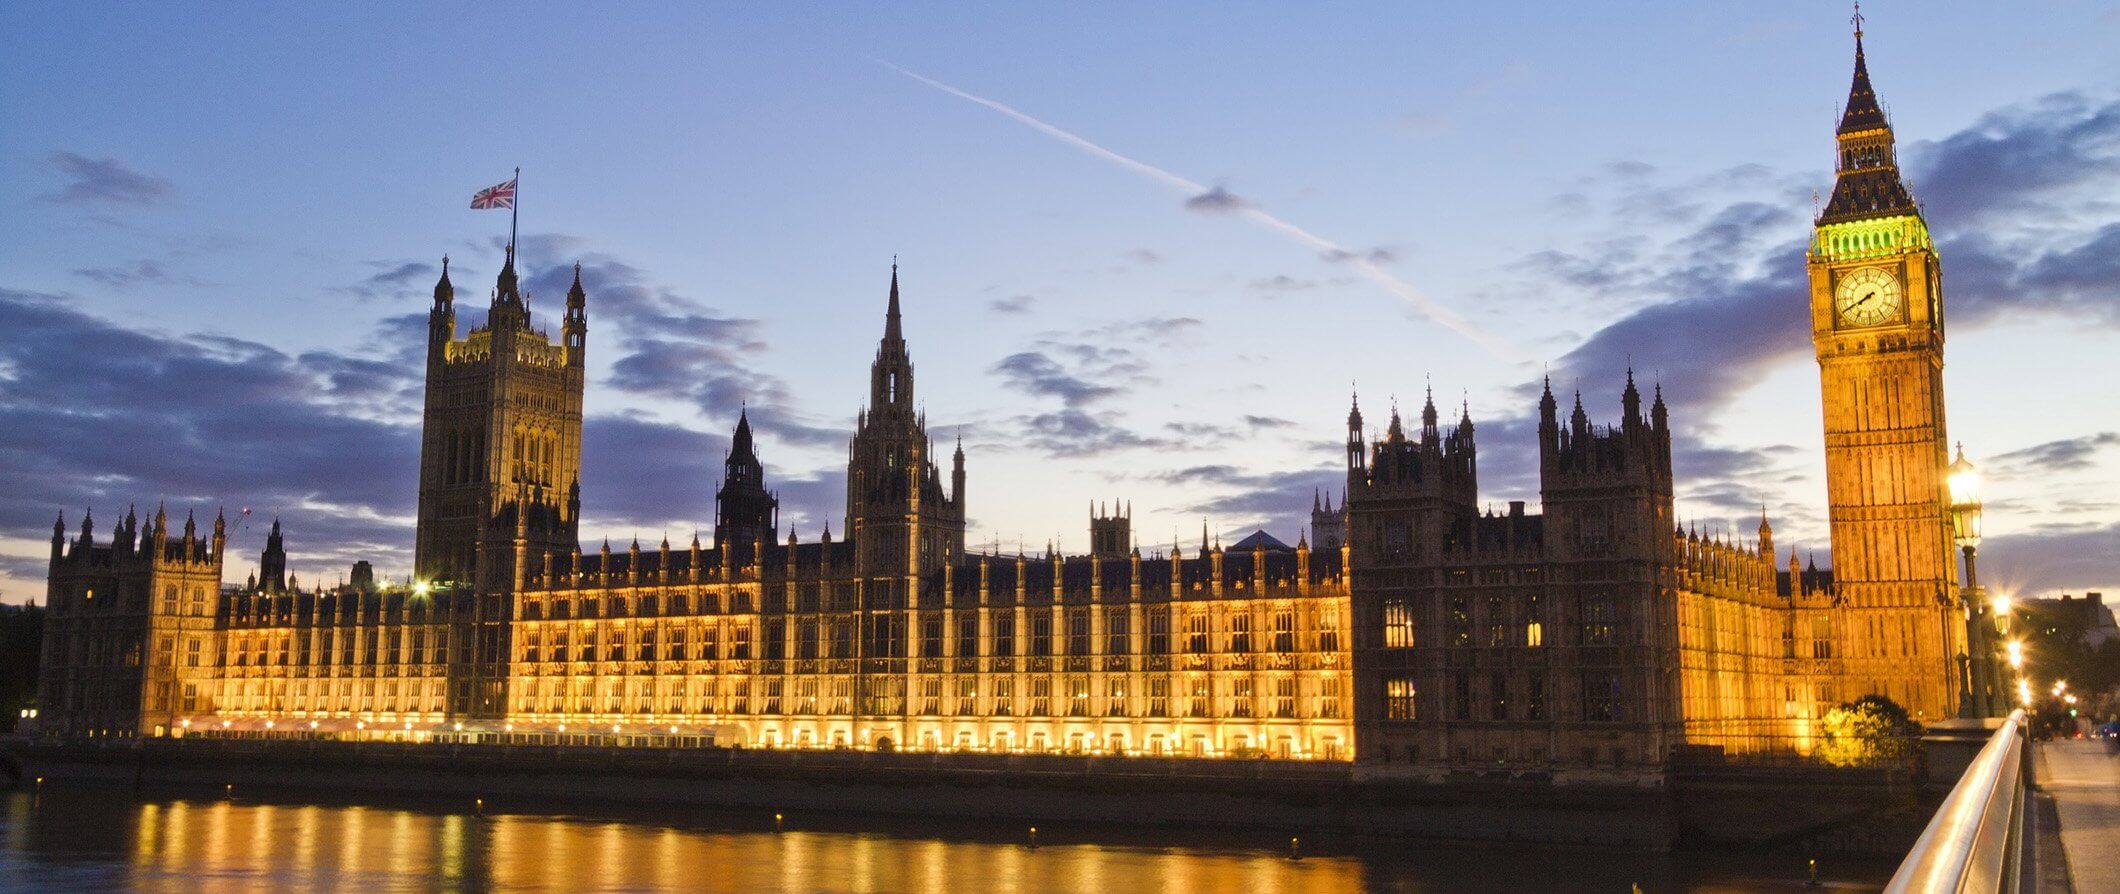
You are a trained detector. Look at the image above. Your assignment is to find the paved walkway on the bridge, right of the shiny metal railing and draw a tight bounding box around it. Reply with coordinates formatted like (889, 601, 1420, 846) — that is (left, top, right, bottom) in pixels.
(2037, 739, 2120, 894)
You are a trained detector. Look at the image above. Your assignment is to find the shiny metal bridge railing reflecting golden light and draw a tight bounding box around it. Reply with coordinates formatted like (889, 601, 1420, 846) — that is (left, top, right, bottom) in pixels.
(1885, 710, 2031, 894)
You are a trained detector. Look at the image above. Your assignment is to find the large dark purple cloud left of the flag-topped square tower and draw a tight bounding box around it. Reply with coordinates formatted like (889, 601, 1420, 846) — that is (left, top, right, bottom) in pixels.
(0, 290, 418, 593)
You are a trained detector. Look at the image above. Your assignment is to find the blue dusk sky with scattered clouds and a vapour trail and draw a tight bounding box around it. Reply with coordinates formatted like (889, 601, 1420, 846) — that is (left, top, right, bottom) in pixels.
(0, 0, 2120, 602)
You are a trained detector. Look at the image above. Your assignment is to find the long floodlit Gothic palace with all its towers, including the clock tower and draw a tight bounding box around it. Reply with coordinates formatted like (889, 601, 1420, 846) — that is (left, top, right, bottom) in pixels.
(40, 32, 1963, 780)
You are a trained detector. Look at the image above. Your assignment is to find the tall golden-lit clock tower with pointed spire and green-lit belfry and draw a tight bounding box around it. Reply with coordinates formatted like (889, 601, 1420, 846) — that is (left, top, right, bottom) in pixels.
(1808, 19, 1963, 720)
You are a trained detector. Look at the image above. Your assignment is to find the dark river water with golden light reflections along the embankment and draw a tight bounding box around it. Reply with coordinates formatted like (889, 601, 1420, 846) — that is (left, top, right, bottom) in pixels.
(0, 790, 1891, 894)
